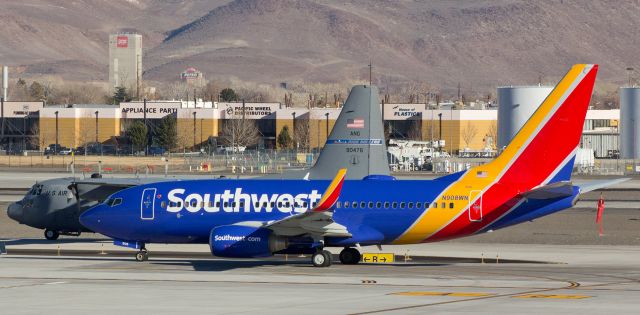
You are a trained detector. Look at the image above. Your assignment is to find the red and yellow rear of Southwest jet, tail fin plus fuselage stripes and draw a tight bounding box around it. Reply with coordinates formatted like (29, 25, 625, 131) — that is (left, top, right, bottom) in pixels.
(395, 64, 598, 244)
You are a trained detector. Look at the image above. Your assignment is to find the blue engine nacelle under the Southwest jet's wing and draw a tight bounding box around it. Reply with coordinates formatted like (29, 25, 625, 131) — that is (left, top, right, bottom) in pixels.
(209, 225, 289, 258)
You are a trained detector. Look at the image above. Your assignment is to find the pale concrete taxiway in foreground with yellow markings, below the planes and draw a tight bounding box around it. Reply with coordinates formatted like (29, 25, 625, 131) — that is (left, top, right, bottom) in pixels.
(0, 244, 640, 314)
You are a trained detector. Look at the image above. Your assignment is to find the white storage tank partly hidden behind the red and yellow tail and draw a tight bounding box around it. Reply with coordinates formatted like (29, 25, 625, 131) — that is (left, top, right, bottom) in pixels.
(497, 86, 553, 150)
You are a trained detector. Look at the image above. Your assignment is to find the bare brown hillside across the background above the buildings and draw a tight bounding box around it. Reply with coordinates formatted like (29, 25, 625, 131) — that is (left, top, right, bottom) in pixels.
(0, 0, 640, 89)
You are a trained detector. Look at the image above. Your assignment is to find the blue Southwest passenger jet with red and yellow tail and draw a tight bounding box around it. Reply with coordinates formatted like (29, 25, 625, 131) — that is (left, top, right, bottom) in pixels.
(80, 64, 617, 266)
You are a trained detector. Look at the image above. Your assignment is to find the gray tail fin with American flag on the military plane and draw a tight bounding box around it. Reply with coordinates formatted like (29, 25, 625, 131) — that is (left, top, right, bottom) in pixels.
(261, 85, 390, 179)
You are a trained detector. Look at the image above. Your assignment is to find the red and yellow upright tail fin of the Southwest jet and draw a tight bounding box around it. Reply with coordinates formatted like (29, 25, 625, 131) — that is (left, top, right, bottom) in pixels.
(480, 64, 598, 184)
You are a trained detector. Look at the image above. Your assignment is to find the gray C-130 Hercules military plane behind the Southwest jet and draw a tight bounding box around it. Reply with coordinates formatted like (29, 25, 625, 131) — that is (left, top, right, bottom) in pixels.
(7, 85, 390, 240)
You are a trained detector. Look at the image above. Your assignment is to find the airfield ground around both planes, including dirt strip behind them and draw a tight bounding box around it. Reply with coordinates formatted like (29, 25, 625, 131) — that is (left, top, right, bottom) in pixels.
(0, 174, 640, 315)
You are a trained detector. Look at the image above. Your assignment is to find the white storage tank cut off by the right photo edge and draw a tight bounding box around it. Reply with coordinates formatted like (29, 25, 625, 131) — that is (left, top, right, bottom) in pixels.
(620, 87, 640, 159)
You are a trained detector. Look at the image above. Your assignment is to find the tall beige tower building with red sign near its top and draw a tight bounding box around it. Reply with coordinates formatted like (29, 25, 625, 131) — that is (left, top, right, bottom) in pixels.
(109, 33, 142, 95)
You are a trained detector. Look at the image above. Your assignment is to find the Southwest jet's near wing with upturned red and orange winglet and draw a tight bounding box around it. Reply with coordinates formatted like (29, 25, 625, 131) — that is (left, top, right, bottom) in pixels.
(263, 168, 351, 237)
